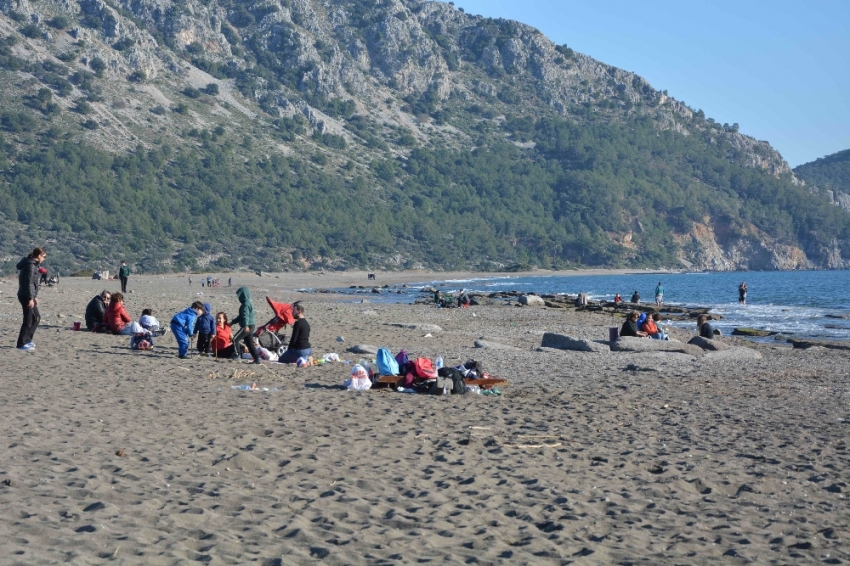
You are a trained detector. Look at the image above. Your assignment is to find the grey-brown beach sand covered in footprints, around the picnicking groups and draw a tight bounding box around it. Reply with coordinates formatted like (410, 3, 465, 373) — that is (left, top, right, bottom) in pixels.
(0, 272, 850, 564)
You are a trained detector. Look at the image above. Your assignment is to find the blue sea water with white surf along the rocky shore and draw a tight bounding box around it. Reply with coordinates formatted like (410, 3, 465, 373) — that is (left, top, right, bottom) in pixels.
(328, 271, 850, 340)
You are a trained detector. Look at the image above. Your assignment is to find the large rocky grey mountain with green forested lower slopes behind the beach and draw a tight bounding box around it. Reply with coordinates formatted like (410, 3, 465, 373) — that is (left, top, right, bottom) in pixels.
(0, 0, 850, 271)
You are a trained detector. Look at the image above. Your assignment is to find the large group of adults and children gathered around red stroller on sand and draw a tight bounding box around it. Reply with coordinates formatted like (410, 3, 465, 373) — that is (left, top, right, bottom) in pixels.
(80, 287, 313, 364)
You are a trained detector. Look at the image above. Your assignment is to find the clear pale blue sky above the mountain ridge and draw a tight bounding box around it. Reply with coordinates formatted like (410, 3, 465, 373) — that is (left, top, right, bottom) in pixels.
(448, 0, 850, 167)
